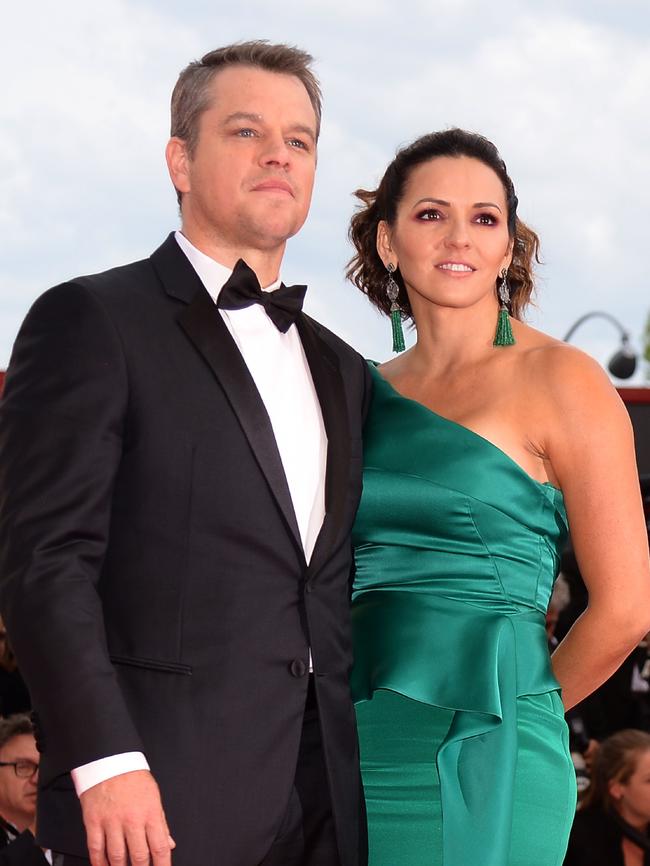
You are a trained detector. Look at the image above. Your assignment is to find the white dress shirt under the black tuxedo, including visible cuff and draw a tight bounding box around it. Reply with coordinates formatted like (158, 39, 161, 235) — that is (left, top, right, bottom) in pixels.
(72, 232, 327, 795)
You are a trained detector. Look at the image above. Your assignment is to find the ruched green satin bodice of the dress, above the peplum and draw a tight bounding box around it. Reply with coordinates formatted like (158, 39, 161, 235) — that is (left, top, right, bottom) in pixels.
(354, 367, 566, 615)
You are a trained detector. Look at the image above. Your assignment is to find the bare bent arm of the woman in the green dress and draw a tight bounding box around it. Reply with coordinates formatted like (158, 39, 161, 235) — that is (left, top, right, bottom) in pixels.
(540, 346, 650, 709)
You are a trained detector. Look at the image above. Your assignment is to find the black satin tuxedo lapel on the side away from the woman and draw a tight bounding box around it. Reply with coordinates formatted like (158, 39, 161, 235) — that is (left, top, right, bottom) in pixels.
(172, 280, 304, 556)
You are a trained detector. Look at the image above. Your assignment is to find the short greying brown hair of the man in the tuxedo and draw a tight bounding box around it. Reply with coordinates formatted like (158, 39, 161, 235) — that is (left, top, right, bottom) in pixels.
(171, 39, 322, 156)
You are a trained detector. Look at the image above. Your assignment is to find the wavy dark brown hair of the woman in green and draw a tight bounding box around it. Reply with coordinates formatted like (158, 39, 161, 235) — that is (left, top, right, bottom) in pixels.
(346, 129, 539, 319)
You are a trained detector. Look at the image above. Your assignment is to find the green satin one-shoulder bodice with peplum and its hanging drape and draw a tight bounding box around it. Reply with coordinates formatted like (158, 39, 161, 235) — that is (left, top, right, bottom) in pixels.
(352, 366, 567, 866)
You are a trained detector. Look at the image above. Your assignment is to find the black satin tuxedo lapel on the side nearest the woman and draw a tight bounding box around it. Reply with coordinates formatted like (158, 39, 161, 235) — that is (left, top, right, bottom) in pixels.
(296, 315, 350, 573)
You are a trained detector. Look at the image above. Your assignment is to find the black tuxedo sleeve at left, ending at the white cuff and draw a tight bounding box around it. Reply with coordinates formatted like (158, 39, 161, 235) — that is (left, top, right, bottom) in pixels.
(0, 283, 143, 783)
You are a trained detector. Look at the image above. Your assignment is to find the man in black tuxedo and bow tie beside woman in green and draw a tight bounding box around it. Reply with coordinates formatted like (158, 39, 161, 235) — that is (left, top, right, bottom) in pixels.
(0, 42, 369, 866)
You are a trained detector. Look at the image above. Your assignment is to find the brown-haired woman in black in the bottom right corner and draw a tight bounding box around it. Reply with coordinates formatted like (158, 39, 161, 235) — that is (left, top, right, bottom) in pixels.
(564, 729, 650, 866)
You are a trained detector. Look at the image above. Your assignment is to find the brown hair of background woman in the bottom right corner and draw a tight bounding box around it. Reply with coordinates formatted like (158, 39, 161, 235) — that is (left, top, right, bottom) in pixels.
(582, 728, 650, 810)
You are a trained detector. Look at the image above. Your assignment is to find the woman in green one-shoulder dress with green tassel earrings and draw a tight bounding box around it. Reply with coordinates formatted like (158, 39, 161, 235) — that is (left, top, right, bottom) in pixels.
(349, 130, 650, 866)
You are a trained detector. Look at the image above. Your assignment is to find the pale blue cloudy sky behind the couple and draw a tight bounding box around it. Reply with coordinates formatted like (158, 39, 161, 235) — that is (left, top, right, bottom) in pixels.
(5, 0, 650, 382)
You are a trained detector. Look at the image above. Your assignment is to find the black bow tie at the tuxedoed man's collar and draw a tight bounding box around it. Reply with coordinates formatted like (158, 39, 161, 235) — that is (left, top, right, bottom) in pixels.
(217, 259, 307, 334)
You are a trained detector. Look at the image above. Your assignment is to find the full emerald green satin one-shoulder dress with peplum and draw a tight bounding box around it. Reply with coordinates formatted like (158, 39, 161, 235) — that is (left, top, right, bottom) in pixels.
(352, 366, 576, 866)
